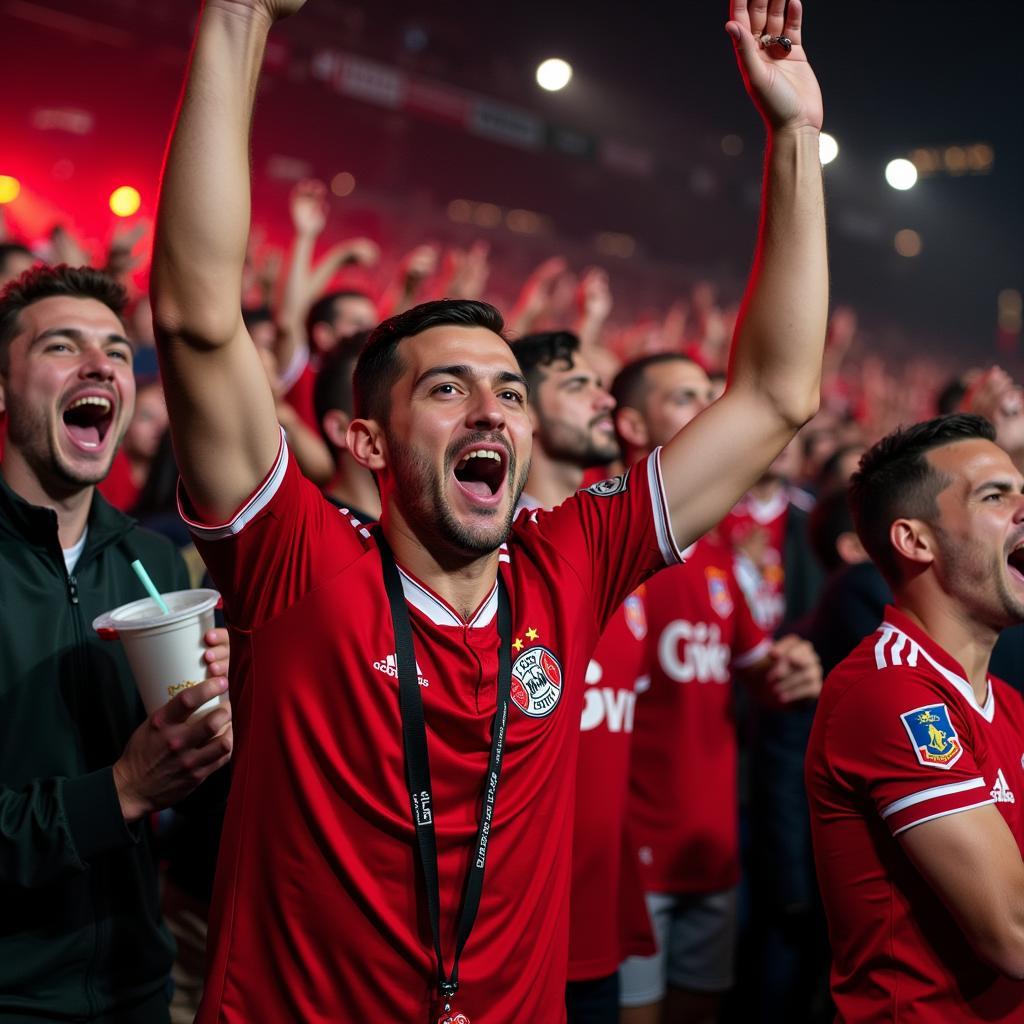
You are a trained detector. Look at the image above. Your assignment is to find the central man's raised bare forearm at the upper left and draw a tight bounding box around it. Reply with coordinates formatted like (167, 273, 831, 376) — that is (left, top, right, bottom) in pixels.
(152, 3, 269, 345)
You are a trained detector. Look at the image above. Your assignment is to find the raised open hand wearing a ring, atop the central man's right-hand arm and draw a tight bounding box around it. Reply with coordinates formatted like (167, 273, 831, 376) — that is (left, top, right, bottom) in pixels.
(725, 0, 823, 130)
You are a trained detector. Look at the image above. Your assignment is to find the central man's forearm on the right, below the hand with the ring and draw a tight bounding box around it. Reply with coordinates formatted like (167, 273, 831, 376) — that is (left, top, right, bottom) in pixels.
(730, 128, 828, 426)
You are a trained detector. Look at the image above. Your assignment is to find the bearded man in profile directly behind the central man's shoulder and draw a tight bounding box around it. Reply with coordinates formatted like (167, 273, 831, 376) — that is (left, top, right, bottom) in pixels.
(512, 331, 653, 1024)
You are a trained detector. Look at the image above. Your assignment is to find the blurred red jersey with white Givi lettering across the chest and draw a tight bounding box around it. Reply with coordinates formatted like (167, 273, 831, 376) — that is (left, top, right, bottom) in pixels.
(629, 538, 769, 893)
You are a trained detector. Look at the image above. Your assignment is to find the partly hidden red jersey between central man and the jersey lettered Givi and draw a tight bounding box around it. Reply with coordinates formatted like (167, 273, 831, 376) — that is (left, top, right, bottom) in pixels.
(568, 584, 653, 981)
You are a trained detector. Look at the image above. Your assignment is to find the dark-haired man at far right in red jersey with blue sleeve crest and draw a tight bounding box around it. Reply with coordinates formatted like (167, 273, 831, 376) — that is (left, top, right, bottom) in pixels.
(806, 415, 1024, 1024)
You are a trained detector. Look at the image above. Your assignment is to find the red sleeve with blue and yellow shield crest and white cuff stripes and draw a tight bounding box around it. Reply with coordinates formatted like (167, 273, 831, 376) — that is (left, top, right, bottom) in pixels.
(824, 666, 992, 836)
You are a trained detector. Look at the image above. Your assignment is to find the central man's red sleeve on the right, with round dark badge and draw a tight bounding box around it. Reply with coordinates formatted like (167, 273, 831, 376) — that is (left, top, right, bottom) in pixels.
(515, 449, 683, 630)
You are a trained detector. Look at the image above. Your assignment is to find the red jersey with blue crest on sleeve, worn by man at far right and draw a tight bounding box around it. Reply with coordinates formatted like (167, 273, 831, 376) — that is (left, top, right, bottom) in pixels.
(806, 608, 1024, 1024)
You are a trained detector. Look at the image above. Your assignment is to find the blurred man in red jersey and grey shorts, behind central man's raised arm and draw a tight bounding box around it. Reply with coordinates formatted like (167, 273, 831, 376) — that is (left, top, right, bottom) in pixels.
(612, 353, 821, 1024)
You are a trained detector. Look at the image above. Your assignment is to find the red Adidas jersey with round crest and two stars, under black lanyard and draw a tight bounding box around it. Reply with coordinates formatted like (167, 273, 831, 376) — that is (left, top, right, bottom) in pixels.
(181, 434, 679, 1024)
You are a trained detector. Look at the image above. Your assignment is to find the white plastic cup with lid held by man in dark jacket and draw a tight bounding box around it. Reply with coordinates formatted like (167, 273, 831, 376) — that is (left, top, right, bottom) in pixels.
(92, 590, 223, 716)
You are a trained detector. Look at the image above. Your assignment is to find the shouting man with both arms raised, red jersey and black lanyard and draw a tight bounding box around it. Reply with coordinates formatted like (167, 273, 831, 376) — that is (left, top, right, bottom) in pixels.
(153, 0, 827, 1024)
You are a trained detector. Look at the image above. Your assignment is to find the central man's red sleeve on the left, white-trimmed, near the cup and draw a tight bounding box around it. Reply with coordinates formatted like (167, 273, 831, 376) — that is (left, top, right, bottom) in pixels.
(178, 433, 370, 630)
